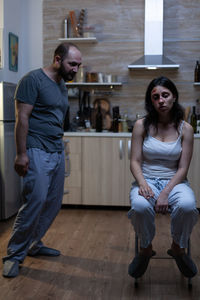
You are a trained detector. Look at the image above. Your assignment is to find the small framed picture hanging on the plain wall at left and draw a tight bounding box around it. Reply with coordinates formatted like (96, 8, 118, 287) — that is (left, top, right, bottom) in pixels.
(8, 32, 18, 72)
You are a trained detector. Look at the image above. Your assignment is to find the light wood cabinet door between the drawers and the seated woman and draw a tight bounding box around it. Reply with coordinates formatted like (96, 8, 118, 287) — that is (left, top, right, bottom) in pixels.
(82, 137, 132, 206)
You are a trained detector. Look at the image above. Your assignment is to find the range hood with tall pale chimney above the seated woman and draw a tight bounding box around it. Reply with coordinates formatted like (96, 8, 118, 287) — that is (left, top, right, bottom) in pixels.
(128, 0, 179, 69)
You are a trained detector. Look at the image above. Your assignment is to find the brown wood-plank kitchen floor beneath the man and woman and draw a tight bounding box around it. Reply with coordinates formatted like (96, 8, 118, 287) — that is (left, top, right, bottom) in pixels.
(0, 208, 200, 300)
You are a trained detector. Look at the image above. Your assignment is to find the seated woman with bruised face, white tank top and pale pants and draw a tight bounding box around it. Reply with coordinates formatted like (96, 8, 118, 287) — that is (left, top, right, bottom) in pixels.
(128, 77, 198, 278)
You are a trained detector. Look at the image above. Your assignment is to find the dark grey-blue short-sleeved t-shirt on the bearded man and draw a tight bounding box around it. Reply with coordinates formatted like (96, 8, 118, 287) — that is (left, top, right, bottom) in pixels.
(15, 69, 68, 152)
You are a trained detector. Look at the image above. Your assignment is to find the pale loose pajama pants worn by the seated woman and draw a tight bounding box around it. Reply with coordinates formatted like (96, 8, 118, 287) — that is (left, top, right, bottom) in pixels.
(128, 179, 198, 248)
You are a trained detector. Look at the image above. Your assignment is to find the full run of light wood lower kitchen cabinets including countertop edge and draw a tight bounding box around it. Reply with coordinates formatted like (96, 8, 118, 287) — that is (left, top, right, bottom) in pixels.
(63, 133, 200, 208)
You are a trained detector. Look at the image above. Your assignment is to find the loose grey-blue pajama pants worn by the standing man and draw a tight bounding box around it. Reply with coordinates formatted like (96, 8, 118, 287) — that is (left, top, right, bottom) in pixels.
(3, 148, 65, 262)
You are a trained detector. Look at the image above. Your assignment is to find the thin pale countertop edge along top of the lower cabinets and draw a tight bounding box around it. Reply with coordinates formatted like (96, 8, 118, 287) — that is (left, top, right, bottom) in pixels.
(64, 131, 200, 138)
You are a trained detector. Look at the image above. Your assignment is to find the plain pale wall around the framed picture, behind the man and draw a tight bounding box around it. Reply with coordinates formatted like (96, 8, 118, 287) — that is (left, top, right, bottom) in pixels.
(0, 0, 43, 83)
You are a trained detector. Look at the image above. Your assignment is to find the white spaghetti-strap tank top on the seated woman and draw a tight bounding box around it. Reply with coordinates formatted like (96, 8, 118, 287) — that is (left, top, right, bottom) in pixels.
(142, 121, 184, 179)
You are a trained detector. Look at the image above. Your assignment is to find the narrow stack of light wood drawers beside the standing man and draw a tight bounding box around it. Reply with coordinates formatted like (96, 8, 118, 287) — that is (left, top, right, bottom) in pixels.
(62, 137, 82, 204)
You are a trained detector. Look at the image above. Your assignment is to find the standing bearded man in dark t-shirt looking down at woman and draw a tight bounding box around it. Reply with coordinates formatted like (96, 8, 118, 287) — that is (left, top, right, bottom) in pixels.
(3, 43, 81, 277)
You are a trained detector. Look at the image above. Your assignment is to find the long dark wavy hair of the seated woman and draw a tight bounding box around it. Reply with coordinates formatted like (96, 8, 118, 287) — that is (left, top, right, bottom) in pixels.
(144, 76, 184, 134)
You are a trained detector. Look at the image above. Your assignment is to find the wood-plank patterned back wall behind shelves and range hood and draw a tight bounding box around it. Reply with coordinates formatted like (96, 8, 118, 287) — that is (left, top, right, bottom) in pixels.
(43, 0, 200, 119)
